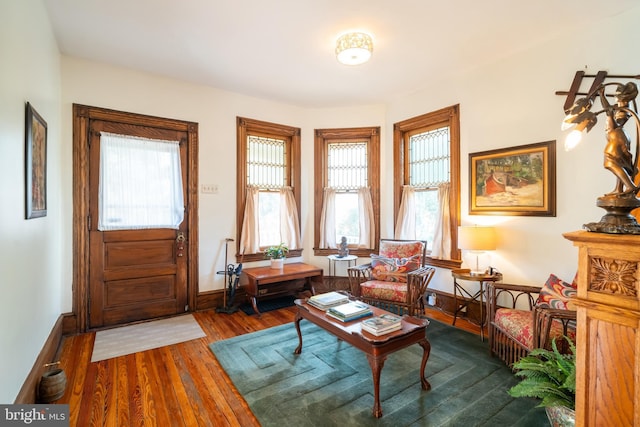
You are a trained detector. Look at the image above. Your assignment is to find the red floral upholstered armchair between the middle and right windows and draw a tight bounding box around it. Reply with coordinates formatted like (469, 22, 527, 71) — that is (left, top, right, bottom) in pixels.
(347, 239, 435, 316)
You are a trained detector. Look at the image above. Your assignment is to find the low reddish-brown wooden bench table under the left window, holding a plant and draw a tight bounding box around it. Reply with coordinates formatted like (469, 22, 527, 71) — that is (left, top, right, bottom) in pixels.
(240, 262, 323, 316)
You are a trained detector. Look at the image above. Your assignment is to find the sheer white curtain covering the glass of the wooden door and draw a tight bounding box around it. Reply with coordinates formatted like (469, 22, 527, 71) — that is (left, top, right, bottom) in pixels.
(98, 132, 184, 231)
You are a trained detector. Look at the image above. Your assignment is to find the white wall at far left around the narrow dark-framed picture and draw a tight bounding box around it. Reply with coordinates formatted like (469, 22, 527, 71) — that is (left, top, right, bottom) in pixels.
(0, 0, 62, 403)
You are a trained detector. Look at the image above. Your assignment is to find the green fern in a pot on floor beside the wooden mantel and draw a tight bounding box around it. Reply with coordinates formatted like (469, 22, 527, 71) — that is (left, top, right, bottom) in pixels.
(509, 337, 576, 427)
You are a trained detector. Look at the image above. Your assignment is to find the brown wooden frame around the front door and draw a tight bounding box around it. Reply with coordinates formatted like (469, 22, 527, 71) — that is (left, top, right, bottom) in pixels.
(71, 104, 199, 333)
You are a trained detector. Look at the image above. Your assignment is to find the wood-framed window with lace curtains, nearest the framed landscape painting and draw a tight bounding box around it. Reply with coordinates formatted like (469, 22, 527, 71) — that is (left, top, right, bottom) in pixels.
(394, 105, 460, 268)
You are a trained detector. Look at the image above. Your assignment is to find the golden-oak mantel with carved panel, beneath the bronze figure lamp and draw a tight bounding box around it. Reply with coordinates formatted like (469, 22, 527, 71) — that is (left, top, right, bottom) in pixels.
(563, 231, 640, 426)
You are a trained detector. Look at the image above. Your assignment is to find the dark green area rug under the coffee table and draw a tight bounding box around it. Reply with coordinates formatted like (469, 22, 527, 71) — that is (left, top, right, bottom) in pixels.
(210, 320, 549, 427)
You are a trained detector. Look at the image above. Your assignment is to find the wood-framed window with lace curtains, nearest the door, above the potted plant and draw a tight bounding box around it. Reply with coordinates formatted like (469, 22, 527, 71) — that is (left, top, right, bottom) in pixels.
(236, 117, 302, 261)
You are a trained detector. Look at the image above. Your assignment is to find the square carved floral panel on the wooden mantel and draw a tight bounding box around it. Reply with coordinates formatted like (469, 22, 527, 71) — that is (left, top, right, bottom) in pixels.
(589, 258, 638, 297)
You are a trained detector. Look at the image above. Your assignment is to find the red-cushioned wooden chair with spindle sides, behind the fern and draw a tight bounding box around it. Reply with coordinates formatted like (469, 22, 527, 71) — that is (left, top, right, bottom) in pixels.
(487, 274, 577, 366)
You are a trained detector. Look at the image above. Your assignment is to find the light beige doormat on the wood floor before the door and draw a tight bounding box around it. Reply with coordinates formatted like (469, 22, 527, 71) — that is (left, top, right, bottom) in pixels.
(91, 314, 206, 362)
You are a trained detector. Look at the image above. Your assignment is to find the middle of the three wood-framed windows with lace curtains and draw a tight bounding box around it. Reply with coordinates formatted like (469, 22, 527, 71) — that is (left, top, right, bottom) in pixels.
(314, 127, 380, 256)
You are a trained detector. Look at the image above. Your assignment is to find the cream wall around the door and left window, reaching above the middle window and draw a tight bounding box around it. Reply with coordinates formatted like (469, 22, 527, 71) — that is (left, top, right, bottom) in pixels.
(62, 57, 385, 298)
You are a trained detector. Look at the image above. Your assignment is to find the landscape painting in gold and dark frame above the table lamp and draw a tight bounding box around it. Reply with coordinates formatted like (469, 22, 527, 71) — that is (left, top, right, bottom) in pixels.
(469, 141, 556, 216)
